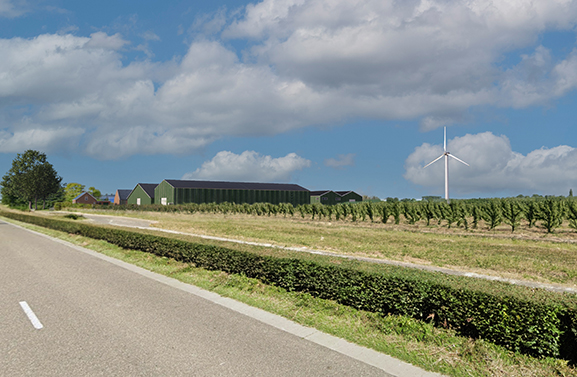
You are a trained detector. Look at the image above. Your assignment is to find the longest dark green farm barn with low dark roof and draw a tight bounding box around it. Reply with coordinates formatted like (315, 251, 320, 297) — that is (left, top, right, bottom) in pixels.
(154, 179, 310, 206)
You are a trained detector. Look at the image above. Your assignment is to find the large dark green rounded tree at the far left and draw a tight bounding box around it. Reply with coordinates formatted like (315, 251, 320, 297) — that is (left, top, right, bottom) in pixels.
(0, 149, 62, 209)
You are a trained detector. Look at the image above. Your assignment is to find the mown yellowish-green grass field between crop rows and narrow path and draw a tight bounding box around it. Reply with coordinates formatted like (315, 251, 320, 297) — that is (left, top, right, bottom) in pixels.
(64, 211, 577, 288)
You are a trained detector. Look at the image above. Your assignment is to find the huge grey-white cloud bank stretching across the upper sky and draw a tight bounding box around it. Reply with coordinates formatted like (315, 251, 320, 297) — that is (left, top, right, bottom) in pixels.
(0, 0, 577, 159)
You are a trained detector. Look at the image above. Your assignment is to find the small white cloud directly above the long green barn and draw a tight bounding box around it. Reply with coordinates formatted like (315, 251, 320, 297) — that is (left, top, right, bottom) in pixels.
(182, 151, 311, 182)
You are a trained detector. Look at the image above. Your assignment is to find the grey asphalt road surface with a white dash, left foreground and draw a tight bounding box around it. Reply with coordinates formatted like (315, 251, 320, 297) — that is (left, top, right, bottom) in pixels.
(0, 221, 412, 376)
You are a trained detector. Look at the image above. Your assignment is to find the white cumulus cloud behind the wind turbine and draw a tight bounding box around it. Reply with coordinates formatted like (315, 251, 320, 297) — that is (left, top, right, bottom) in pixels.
(404, 132, 577, 195)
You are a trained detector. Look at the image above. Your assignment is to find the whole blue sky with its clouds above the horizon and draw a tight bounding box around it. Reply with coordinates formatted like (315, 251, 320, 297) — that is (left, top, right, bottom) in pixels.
(0, 0, 577, 198)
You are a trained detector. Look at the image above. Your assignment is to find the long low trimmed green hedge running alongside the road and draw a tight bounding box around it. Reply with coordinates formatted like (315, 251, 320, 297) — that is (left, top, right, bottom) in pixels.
(0, 211, 577, 362)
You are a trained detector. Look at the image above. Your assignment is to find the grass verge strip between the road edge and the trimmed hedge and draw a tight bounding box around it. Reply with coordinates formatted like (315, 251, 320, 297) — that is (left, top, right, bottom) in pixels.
(5, 220, 577, 376)
